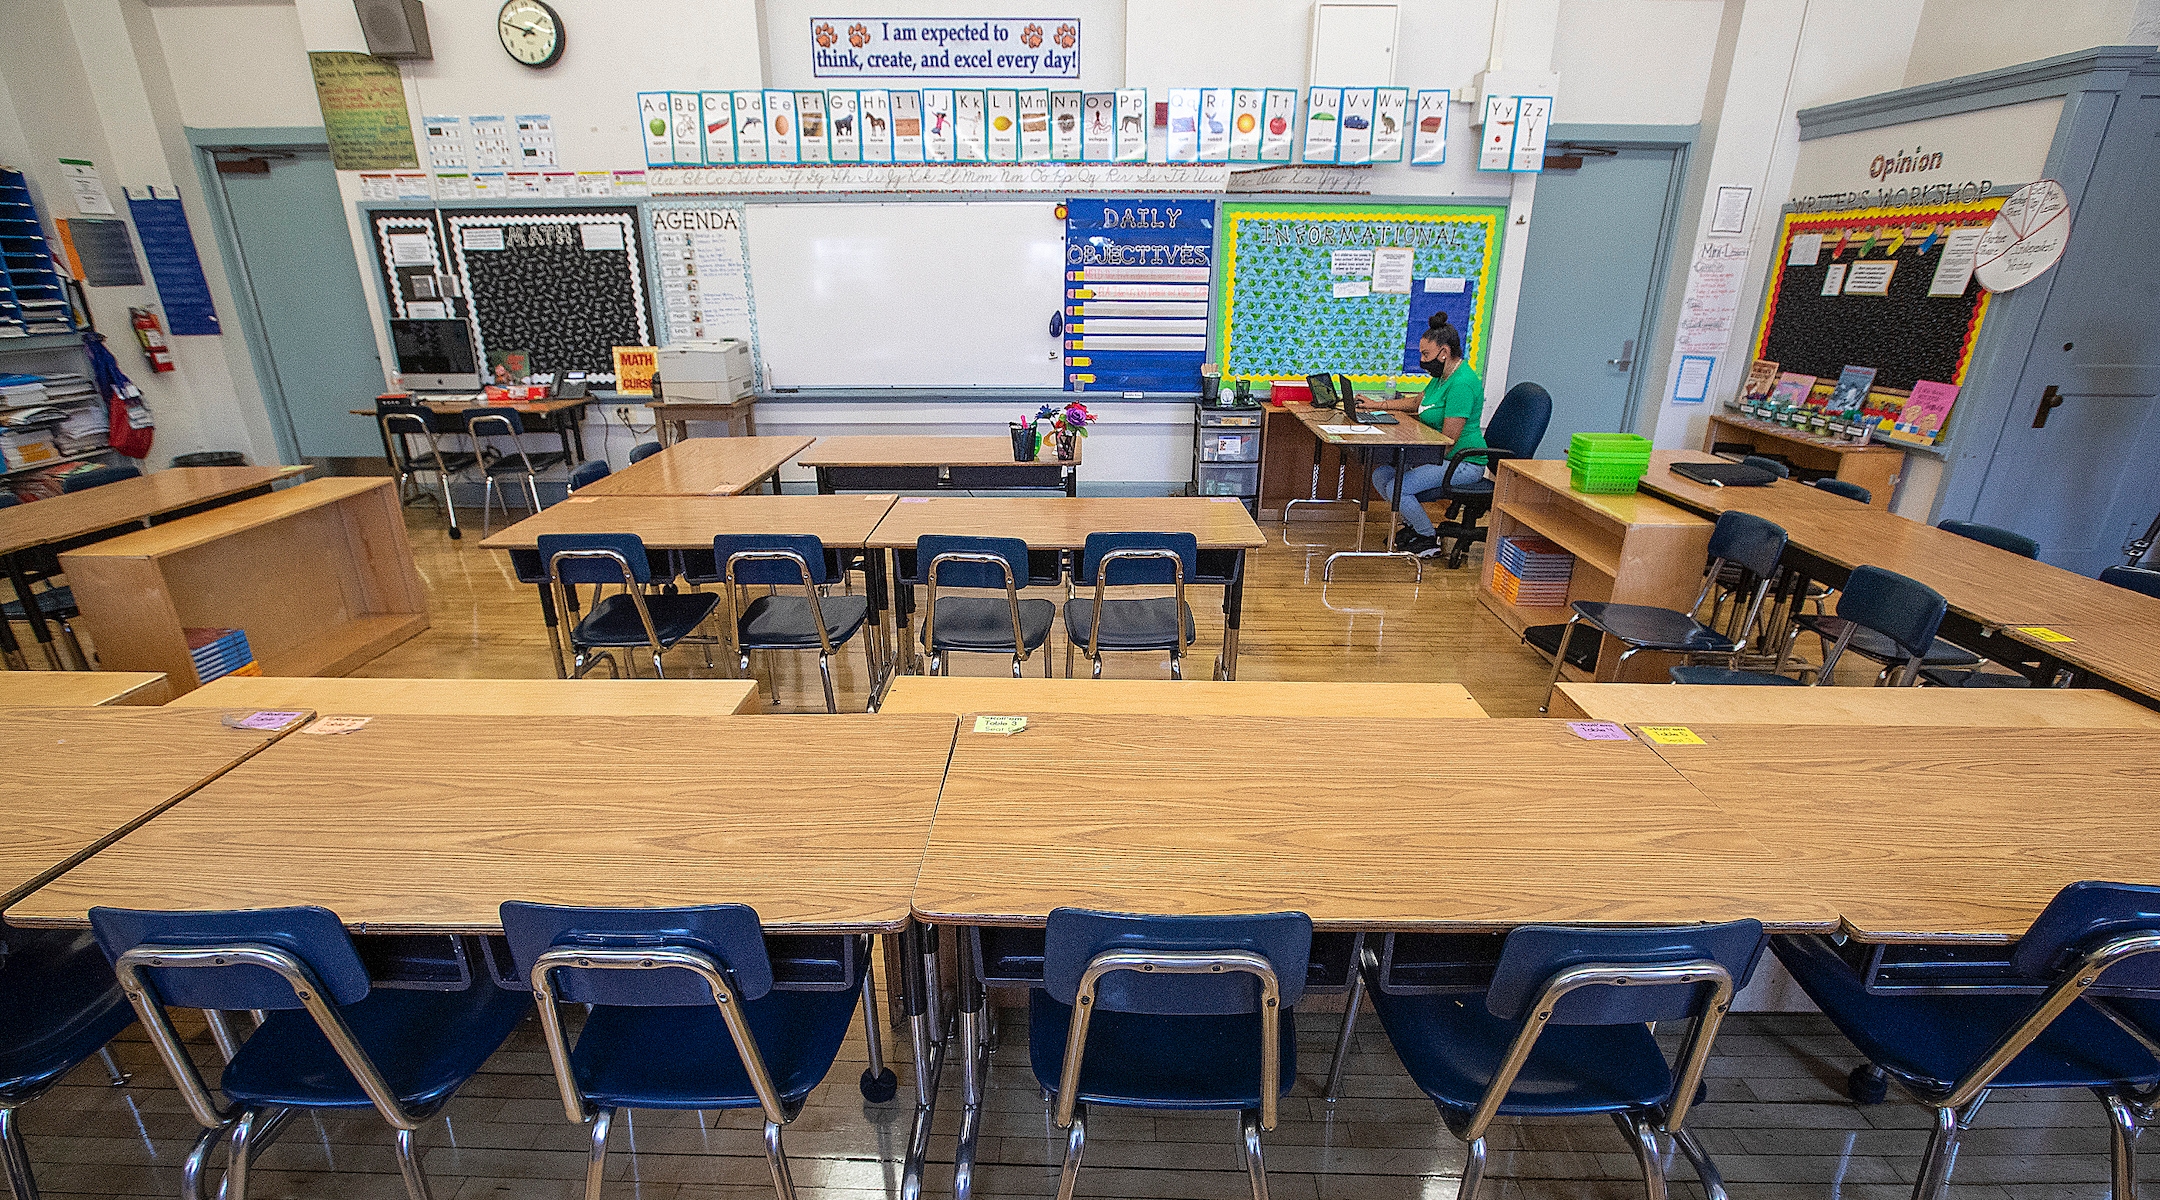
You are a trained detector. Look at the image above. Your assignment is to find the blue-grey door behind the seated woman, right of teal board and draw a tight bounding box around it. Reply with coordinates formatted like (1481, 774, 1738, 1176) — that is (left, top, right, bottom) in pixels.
(1508, 147, 1680, 448)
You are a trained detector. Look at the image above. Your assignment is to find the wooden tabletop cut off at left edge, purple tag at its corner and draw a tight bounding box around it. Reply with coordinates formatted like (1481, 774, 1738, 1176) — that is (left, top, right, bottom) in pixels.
(0, 708, 293, 909)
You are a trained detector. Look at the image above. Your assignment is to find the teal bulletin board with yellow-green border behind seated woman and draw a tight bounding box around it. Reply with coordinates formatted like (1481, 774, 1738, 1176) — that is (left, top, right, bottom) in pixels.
(1214, 203, 1508, 386)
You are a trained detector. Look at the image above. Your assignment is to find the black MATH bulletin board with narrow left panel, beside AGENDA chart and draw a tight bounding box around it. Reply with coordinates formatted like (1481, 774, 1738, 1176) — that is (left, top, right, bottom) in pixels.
(374, 205, 652, 384)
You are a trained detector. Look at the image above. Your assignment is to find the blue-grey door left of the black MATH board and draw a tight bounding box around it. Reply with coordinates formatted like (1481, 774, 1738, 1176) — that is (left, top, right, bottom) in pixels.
(214, 145, 382, 458)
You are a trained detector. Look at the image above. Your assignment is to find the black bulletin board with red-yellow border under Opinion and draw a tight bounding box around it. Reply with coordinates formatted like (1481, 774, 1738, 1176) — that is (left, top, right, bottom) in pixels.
(1754, 199, 2002, 391)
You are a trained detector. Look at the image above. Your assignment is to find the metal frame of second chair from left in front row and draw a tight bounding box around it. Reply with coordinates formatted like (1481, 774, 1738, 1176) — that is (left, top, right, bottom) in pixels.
(112, 941, 441, 1200)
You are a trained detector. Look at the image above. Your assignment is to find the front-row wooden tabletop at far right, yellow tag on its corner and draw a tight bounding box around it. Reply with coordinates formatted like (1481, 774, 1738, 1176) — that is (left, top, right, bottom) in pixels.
(1632, 725, 2160, 943)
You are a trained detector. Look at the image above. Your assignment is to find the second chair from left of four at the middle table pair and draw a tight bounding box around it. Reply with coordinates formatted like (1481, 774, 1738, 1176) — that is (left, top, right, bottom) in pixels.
(712, 533, 879, 712)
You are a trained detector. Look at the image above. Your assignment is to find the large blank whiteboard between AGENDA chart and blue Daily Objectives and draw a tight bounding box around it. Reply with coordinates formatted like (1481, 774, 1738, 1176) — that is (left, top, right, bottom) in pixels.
(747, 201, 1065, 388)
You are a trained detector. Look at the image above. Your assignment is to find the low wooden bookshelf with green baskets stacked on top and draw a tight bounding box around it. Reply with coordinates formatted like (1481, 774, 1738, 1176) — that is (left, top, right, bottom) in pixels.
(1477, 460, 1711, 682)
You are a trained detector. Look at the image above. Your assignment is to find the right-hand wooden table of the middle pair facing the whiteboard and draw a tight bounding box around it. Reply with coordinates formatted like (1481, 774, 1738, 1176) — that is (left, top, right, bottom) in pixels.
(868, 496, 1268, 680)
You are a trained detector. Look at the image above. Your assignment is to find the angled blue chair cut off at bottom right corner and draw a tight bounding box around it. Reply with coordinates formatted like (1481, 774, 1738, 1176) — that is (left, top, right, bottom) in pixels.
(1771, 883, 2160, 1200)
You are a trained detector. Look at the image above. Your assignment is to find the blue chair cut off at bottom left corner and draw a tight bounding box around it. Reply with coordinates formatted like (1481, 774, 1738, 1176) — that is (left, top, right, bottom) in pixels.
(0, 928, 134, 1200)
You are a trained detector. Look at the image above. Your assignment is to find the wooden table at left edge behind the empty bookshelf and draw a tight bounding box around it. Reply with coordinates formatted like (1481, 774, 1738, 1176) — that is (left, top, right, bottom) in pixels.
(0, 466, 309, 671)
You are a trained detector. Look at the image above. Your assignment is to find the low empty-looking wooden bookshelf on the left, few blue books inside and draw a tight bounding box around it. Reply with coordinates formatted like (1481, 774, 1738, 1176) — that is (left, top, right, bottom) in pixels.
(60, 479, 428, 695)
